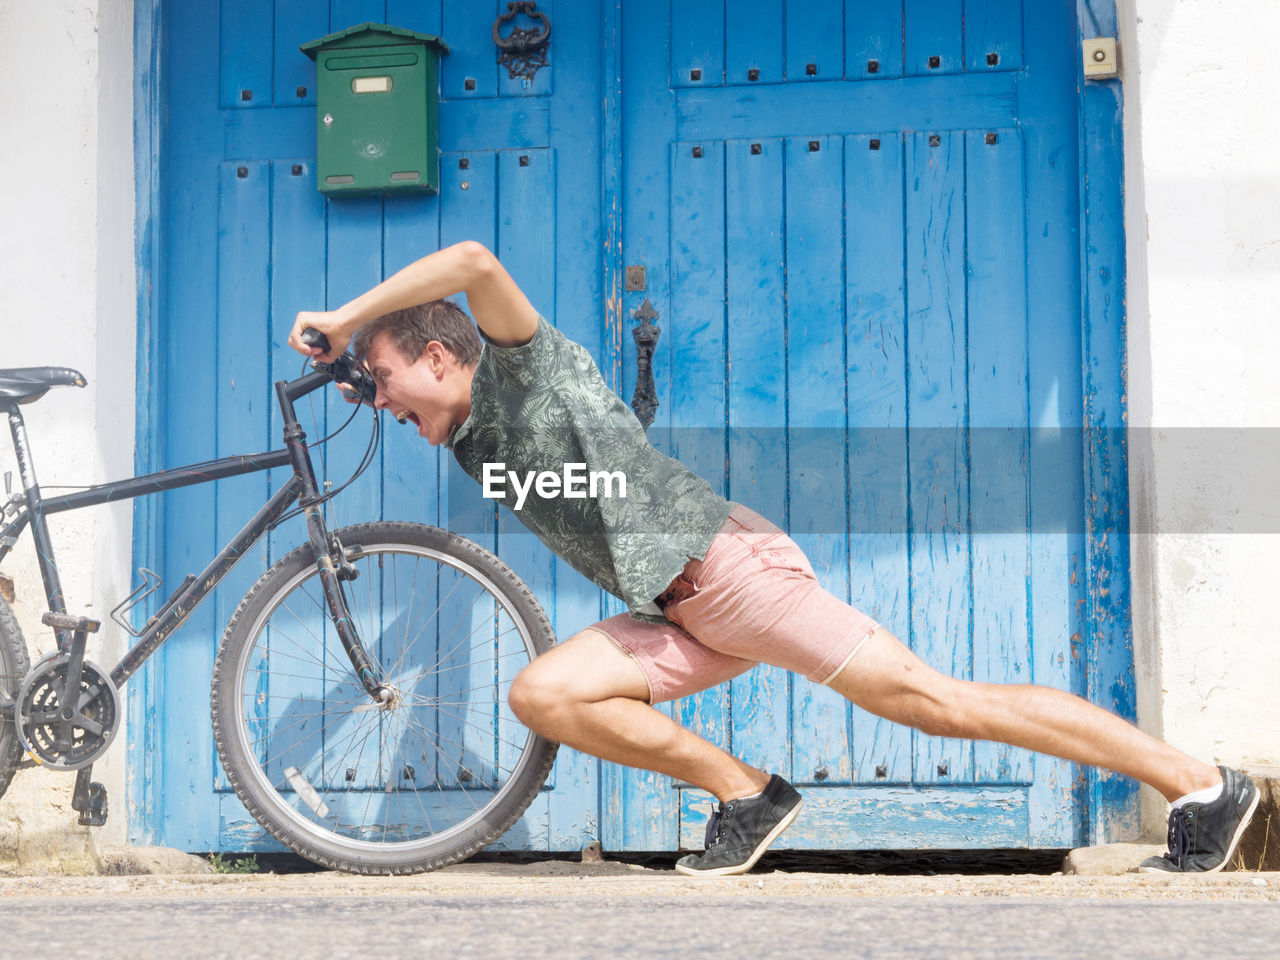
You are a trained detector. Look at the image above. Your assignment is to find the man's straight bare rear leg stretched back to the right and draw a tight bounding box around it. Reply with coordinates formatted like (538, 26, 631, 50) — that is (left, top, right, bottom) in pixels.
(831, 627, 1221, 800)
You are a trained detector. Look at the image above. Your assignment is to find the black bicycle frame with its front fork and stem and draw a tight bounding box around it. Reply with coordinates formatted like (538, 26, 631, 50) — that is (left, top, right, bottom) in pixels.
(0, 360, 389, 700)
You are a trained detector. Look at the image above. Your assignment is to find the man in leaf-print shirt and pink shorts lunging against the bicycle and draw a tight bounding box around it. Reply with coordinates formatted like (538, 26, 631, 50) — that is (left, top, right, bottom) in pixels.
(289, 242, 1258, 876)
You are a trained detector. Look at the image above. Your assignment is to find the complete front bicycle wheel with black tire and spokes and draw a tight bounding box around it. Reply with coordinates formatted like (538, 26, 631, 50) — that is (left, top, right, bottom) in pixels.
(211, 521, 557, 874)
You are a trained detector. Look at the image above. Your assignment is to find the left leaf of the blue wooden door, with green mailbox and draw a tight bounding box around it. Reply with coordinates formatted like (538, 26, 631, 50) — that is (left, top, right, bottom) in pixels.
(133, 0, 605, 850)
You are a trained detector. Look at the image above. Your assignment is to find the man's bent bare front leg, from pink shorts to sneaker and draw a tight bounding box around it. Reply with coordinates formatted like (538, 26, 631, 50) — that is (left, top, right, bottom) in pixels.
(509, 630, 769, 800)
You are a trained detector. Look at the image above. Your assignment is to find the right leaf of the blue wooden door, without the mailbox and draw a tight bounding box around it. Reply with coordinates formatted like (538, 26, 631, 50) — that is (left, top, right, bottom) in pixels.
(604, 0, 1105, 849)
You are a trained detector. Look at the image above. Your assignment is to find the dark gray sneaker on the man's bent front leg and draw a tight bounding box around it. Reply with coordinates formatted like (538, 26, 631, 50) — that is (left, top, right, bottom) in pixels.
(676, 773, 804, 877)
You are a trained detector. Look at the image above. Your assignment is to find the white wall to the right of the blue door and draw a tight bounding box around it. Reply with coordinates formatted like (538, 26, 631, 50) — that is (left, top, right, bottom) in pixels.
(1119, 0, 1280, 827)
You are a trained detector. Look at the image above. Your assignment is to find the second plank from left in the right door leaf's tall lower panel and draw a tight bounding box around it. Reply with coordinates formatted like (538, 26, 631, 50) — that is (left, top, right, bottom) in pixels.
(724, 140, 791, 778)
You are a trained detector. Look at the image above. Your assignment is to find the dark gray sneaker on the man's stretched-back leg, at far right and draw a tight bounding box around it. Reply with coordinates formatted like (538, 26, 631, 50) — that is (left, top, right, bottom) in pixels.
(1139, 767, 1258, 873)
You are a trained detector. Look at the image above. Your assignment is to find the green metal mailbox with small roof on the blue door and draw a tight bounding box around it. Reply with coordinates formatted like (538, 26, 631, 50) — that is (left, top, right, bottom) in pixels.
(298, 23, 448, 196)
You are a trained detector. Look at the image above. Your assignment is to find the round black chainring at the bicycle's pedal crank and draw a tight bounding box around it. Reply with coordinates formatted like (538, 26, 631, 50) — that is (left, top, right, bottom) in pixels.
(14, 653, 120, 771)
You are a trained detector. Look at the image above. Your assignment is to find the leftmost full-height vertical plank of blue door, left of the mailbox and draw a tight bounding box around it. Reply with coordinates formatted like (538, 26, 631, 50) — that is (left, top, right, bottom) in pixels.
(158, 5, 225, 850)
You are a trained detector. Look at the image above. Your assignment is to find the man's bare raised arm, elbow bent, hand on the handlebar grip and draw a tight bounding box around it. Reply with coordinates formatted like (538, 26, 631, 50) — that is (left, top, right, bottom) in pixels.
(289, 241, 538, 360)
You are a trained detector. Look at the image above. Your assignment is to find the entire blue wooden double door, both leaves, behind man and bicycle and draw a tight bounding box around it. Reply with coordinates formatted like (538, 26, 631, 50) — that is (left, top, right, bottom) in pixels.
(140, 0, 1121, 850)
